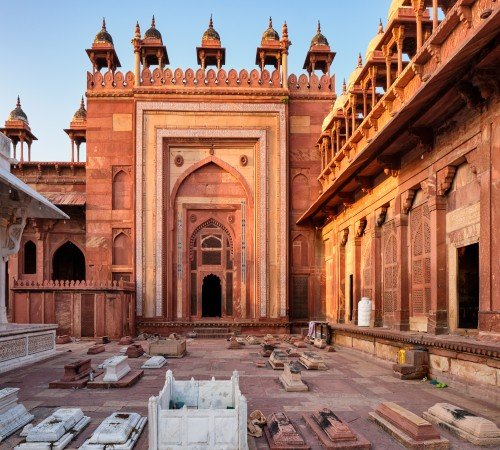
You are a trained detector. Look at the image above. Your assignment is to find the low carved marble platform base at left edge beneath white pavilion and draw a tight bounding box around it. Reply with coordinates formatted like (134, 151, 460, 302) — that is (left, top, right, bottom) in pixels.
(0, 323, 57, 373)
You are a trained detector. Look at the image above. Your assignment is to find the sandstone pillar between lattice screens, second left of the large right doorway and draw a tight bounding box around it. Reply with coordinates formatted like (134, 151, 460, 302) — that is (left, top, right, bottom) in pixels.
(394, 213, 410, 331)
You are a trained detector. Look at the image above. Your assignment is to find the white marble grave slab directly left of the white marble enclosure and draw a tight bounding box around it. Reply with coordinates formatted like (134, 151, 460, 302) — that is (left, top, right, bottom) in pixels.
(80, 412, 147, 450)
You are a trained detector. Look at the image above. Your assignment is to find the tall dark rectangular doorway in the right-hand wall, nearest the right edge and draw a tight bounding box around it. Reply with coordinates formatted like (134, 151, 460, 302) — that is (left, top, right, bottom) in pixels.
(457, 244, 479, 328)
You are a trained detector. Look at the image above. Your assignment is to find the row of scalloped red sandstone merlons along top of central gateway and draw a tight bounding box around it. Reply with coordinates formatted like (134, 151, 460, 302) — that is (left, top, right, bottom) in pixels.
(87, 67, 335, 96)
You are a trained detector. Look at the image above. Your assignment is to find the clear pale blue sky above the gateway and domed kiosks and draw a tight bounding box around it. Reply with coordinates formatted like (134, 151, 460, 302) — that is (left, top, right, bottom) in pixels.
(0, 0, 391, 161)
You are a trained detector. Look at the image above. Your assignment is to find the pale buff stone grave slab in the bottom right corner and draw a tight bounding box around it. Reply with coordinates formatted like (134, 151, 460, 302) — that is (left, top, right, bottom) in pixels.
(423, 403, 500, 448)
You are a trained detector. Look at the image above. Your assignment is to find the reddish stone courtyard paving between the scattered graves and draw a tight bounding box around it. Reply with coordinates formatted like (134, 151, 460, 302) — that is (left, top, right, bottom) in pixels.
(0, 340, 500, 450)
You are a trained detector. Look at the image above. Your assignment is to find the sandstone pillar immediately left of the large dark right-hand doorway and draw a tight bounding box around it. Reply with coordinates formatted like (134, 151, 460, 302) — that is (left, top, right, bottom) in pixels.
(427, 188, 448, 334)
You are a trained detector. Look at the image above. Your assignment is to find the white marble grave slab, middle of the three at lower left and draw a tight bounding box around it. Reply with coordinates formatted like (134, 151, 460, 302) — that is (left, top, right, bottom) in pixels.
(15, 408, 90, 450)
